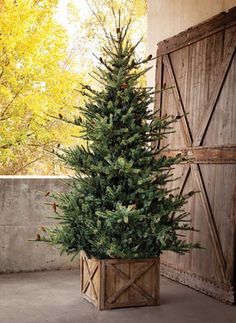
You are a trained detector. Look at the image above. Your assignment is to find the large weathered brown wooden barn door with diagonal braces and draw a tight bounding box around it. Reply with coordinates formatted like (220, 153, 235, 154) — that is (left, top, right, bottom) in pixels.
(155, 8, 236, 303)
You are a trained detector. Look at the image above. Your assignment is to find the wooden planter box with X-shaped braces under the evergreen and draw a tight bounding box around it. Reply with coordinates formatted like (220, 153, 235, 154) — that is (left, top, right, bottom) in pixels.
(80, 251, 160, 310)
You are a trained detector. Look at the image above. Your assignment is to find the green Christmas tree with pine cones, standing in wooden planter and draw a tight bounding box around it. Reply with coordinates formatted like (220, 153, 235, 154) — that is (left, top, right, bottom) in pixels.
(40, 18, 199, 258)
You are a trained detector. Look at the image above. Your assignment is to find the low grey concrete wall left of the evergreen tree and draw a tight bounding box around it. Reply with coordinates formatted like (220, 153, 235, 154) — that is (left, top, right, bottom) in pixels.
(0, 176, 79, 273)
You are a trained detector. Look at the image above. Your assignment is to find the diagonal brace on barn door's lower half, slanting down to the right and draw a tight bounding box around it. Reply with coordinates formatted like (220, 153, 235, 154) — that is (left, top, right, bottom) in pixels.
(191, 164, 226, 282)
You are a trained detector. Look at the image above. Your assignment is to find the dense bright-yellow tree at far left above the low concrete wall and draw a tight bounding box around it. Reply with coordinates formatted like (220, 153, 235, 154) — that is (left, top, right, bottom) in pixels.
(0, 0, 81, 175)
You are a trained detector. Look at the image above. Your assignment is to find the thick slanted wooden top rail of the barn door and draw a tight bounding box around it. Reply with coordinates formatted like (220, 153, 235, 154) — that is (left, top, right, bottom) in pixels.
(157, 7, 236, 56)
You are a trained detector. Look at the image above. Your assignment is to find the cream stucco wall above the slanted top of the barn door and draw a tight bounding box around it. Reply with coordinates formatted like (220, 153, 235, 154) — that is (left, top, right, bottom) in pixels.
(148, 0, 236, 86)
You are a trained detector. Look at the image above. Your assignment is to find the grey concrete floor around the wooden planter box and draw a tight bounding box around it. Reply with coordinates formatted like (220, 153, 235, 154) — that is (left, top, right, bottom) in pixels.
(0, 271, 236, 323)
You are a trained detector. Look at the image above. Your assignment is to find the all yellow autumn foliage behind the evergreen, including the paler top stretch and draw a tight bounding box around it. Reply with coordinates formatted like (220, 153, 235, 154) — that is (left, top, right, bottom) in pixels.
(0, 0, 146, 175)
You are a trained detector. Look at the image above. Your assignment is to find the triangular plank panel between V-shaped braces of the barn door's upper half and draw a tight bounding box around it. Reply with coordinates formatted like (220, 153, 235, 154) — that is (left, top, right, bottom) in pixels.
(184, 31, 224, 139)
